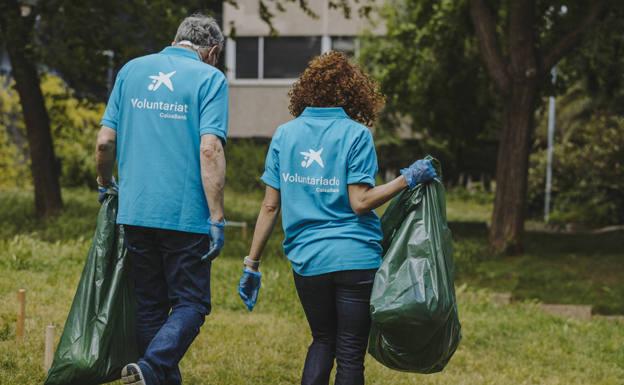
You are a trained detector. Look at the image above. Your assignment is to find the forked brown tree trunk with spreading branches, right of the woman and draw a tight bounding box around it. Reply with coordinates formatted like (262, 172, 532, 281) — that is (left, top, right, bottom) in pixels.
(470, 0, 606, 254)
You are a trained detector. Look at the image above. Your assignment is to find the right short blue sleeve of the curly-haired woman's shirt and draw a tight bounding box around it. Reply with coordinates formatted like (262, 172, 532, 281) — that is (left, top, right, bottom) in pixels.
(347, 129, 377, 186)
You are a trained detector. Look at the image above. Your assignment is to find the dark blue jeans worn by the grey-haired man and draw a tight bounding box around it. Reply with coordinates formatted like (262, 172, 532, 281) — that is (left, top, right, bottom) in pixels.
(124, 226, 211, 385)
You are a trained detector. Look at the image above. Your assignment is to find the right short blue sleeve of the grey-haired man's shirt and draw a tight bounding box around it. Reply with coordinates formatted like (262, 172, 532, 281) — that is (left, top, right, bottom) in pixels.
(199, 73, 228, 143)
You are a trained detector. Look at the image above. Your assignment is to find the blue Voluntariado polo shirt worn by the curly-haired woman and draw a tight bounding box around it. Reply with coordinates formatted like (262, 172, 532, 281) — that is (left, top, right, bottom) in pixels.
(262, 107, 382, 275)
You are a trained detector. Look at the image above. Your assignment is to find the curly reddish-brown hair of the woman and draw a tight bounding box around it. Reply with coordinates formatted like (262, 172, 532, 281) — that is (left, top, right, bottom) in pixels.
(288, 51, 385, 127)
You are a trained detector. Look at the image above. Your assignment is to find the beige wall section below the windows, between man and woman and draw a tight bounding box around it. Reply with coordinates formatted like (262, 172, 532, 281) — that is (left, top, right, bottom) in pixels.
(229, 83, 293, 138)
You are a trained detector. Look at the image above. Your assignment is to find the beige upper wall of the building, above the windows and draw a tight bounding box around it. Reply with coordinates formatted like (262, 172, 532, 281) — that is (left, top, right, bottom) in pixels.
(223, 0, 385, 36)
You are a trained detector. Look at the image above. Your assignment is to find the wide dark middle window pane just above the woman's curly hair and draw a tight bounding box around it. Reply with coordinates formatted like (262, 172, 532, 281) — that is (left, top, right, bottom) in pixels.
(264, 36, 321, 79)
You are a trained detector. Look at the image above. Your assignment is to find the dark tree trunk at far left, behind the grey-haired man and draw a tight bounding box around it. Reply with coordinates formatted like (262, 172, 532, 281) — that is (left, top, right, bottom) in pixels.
(0, 2, 63, 216)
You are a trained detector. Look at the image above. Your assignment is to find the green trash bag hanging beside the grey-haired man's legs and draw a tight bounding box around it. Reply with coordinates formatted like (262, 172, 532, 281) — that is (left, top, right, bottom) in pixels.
(45, 194, 138, 385)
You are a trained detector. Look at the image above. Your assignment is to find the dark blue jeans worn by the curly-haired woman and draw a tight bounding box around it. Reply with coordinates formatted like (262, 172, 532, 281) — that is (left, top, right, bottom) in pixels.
(294, 270, 376, 385)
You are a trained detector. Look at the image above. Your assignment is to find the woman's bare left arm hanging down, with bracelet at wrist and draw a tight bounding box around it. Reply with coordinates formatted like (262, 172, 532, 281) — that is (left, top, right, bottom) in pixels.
(247, 186, 281, 271)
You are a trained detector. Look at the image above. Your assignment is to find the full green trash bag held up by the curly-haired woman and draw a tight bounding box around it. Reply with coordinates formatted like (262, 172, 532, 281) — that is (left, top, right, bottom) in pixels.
(368, 158, 461, 373)
